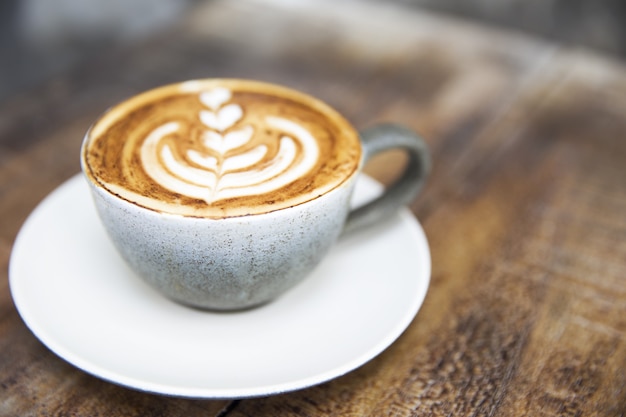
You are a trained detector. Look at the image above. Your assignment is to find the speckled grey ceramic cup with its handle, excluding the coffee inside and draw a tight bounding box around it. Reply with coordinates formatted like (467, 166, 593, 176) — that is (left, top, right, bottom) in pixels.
(82, 85, 430, 310)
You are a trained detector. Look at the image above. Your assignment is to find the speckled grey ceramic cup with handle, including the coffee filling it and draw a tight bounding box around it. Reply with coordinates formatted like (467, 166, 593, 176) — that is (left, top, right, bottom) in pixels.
(81, 79, 430, 310)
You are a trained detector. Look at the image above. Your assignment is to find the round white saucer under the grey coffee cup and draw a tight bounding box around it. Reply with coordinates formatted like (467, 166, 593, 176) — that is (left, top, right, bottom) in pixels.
(9, 176, 430, 398)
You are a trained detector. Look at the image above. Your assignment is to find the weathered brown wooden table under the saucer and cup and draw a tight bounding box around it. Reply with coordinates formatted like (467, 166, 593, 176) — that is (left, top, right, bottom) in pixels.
(0, 0, 626, 417)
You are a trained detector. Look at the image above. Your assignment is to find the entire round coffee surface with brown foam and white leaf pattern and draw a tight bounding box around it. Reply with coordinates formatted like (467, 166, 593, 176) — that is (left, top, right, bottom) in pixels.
(82, 80, 361, 218)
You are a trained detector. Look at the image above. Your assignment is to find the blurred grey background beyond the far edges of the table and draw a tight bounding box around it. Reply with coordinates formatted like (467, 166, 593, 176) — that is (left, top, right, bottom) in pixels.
(0, 0, 626, 101)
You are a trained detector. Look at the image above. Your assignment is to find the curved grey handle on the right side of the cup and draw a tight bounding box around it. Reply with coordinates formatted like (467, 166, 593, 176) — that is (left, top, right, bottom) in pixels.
(343, 124, 431, 233)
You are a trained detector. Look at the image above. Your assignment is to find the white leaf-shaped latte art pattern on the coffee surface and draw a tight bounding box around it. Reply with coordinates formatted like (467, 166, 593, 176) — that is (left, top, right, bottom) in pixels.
(141, 87, 319, 204)
